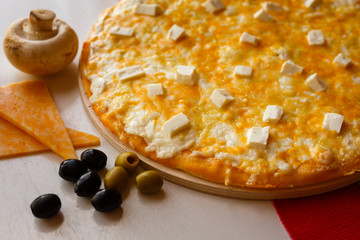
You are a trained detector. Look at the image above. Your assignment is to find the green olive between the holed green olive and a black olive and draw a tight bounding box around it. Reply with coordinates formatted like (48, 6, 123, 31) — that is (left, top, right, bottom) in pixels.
(104, 166, 129, 193)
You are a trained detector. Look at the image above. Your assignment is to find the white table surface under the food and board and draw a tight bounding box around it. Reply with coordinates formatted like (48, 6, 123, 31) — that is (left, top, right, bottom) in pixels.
(0, 0, 290, 240)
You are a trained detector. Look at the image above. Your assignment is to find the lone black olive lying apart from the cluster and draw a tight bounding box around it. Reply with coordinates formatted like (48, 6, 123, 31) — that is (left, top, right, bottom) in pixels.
(30, 193, 61, 218)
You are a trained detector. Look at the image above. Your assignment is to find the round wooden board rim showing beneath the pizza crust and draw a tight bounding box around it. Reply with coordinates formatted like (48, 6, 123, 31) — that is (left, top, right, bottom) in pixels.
(78, 76, 360, 200)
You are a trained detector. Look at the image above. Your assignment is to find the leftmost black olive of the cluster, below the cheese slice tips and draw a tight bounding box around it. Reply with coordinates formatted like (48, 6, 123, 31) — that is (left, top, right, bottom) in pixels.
(59, 159, 87, 182)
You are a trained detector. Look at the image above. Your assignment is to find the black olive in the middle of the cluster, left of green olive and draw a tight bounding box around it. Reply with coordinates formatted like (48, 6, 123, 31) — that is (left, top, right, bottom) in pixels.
(74, 172, 101, 197)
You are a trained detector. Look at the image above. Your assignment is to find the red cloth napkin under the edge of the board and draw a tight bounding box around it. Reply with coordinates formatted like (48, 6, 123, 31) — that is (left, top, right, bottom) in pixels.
(273, 184, 360, 240)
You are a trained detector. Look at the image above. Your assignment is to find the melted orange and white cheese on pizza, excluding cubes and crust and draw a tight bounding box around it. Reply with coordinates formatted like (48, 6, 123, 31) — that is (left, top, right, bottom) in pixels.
(85, 0, 360, 175)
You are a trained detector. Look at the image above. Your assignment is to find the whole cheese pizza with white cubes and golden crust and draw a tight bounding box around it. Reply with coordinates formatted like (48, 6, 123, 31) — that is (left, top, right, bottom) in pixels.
(79, 0, 360, 188)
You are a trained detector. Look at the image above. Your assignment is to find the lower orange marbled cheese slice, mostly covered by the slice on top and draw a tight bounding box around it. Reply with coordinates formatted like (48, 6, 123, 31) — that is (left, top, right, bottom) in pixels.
(0, 118, 100, 158)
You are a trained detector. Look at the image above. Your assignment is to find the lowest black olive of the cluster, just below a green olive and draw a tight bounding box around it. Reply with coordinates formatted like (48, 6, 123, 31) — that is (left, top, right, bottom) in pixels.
(91, 189, 122, 212)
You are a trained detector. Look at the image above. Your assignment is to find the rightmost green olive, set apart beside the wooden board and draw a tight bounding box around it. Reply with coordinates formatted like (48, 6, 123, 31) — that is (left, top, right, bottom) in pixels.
(136, 170, 163, 194)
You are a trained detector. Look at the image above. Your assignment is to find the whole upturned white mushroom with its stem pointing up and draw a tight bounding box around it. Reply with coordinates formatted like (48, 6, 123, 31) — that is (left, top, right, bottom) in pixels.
(4, 9, 79, 75)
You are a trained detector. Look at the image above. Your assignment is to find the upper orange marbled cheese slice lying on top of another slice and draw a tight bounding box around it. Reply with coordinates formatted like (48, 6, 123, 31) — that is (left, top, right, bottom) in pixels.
(0, 80, 77, 159)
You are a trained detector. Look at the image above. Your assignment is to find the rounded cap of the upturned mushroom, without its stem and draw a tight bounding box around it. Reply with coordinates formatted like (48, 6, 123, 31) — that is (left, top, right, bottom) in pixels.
(3, 18, 79, 75)
